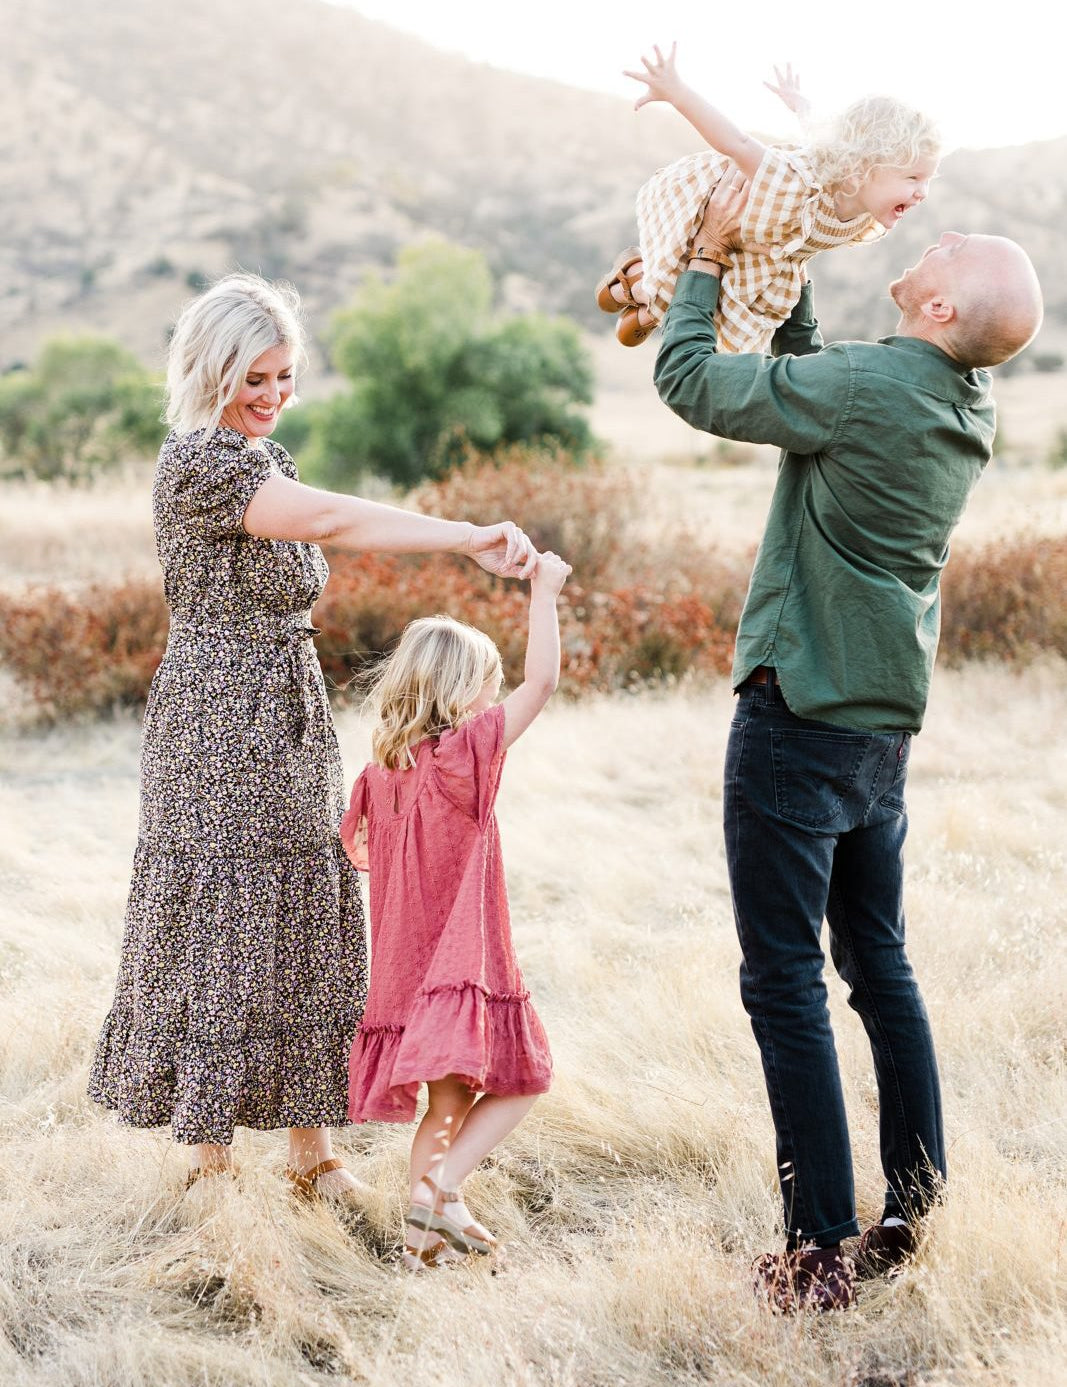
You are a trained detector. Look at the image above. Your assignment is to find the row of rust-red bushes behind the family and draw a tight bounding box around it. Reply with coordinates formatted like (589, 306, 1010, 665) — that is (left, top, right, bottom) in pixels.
(0, 452, 1067, 717)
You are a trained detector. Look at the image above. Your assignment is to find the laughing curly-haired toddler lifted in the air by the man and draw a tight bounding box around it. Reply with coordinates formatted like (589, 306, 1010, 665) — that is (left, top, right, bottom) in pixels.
(597, 46, 941, 352)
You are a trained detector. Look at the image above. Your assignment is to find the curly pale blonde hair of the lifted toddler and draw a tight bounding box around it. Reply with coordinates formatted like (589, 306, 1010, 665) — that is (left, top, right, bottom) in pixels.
(806, 96, 941, 190)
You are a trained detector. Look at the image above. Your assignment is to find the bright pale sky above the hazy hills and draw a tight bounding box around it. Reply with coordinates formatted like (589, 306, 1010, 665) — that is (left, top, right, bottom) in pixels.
(332, 0, 1067, 148)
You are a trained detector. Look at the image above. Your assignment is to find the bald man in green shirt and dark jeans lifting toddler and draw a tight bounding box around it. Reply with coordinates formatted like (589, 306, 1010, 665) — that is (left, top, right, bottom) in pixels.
(655, 175, 1042, 1311)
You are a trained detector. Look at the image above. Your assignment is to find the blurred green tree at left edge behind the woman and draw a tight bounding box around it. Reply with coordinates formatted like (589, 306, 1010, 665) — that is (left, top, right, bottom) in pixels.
(0, 337, 164, 480)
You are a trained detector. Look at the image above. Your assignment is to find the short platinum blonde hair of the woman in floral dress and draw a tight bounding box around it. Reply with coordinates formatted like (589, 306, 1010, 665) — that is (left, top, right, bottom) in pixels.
(165, 275, 307, 434)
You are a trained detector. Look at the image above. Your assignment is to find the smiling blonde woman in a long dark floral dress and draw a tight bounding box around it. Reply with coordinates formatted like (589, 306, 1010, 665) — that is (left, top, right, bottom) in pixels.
(89, 275, 537, 1200)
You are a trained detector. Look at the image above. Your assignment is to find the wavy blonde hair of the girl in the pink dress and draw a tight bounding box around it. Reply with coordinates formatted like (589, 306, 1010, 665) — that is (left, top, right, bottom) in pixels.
(368, 616, 502, 770)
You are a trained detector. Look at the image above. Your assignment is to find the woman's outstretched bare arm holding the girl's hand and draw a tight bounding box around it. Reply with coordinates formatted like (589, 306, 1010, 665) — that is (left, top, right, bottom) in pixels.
(243, 477, 537, 578)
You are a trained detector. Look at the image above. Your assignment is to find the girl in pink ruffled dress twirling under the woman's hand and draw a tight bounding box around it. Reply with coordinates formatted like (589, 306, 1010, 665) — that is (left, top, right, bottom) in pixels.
(341, 553, 570, 1270)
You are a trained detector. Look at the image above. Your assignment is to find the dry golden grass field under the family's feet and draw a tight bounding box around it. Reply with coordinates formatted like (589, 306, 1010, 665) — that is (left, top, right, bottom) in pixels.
(0, 666, 1067, 1387)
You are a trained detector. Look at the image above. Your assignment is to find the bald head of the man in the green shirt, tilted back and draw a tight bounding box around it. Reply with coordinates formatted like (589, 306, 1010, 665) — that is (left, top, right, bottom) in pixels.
(889, 232, 1043, 366)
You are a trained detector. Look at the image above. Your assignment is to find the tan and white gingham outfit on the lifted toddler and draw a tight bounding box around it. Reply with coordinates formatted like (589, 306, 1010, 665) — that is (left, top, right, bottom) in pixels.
(637, 146, 885, 354)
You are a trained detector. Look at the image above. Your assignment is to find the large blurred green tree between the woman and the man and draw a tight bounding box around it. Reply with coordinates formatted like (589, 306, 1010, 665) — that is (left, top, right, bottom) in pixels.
(301, 241, 592, 485)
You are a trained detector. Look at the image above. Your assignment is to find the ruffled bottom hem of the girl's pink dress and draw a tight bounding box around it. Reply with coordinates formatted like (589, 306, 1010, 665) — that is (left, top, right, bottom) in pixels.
(348, 982, 552, 1122)
